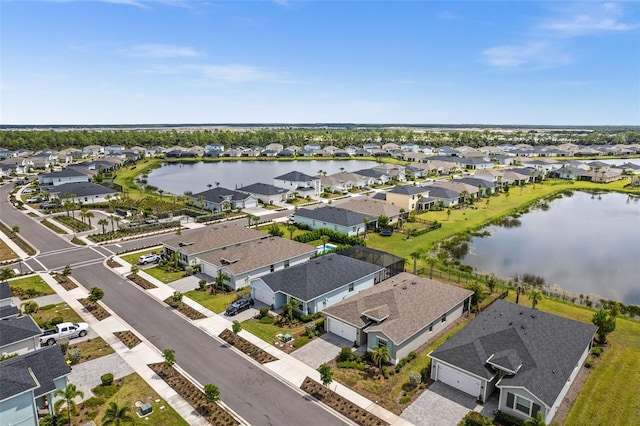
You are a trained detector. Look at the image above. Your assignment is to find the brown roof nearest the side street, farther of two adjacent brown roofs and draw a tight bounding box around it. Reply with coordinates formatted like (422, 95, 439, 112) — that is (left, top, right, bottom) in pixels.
(163, 224, 268, 255)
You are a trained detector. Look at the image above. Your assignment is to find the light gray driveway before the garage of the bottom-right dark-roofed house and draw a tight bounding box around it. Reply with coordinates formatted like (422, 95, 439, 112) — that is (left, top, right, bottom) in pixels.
(400, 382, 498, 426)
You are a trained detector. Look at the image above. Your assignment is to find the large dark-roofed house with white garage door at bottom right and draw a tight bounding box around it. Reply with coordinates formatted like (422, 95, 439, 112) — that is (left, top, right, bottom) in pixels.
(429, 299, 598, 424)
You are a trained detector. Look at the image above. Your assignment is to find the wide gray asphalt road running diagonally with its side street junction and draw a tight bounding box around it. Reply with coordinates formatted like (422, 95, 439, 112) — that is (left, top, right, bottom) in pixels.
(0, 185, 345, 426)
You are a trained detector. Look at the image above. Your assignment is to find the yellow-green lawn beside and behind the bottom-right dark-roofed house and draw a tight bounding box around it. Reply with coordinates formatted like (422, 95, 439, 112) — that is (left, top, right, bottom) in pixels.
(507, 294, 640, 425)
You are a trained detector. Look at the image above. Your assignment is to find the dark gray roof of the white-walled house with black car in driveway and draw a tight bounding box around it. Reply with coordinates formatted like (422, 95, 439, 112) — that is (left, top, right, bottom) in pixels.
(262, 253, 383, 301)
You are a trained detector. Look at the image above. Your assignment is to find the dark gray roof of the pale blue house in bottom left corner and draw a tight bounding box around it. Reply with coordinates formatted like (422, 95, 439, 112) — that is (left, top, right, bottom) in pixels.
(0, 345, 71, 401)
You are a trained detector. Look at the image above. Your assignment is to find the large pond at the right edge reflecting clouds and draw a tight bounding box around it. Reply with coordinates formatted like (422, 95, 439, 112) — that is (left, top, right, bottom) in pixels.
(461, 192, 640, 305)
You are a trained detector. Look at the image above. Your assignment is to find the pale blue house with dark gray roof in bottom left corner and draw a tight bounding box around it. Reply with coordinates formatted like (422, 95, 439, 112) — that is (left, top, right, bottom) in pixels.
(0, 345, 71, 426)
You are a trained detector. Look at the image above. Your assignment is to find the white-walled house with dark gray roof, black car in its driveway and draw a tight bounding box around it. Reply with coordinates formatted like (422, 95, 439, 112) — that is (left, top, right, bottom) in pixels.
(251, 253, 383, 315)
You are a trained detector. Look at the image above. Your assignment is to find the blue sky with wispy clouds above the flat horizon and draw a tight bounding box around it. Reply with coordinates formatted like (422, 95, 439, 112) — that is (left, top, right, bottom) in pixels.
(0, 0, 640, 125)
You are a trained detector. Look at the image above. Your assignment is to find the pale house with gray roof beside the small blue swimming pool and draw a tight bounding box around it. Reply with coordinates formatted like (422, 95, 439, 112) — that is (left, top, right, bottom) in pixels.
(293, 205, 378, 236)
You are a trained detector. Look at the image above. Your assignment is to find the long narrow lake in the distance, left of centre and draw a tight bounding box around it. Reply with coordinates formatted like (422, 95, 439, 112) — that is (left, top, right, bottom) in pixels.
(147, 160, 377, 195)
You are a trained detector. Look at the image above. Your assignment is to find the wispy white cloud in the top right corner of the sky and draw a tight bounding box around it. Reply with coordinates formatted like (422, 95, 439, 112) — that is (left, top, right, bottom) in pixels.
(541, 3, 640, 36)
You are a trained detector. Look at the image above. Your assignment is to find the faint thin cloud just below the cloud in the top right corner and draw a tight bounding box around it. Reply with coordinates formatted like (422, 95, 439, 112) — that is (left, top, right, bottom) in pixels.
(482, 42, 572, 69)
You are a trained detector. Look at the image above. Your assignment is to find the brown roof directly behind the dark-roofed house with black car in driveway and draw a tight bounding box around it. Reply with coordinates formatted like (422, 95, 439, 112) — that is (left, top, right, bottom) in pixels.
(200, 237, 316, 274)
